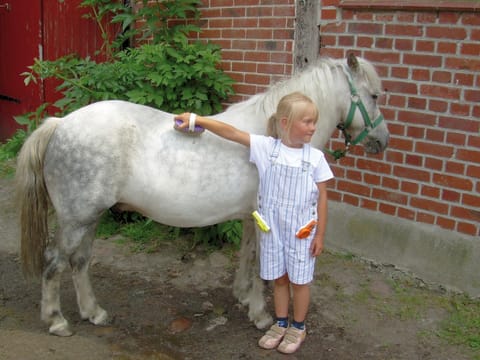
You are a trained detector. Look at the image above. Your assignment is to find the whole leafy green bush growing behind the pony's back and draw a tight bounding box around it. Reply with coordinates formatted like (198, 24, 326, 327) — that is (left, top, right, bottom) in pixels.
(23, 0, 233, 115)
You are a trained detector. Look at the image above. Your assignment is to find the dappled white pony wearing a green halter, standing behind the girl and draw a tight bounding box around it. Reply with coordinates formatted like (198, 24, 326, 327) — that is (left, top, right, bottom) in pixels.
(16, 55, 389, 336)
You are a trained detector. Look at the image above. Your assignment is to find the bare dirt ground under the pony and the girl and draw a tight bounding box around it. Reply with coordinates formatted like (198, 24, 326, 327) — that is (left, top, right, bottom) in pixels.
(0, 180, 473, 360)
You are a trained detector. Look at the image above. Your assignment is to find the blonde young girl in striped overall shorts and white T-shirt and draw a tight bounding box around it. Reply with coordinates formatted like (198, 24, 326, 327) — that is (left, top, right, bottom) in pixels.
(175, 92, 333, 354)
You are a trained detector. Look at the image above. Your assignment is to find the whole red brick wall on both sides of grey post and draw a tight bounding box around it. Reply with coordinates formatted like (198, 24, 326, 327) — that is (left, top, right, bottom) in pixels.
(193, 0, 480, 236)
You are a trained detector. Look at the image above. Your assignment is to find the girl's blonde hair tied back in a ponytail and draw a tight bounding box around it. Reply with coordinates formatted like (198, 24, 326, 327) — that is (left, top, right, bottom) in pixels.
(267, 92, 318, 139)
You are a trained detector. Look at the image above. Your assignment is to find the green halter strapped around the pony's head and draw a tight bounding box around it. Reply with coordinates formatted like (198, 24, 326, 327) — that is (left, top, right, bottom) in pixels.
(325, 67, 383, 160)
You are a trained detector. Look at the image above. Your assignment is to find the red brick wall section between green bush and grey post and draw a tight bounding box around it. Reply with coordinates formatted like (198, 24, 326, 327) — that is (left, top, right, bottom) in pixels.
(193, 0, 295, 102)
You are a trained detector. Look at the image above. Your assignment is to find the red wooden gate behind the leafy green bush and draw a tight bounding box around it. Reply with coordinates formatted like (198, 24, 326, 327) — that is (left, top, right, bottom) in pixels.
(0, 0, 111, 141)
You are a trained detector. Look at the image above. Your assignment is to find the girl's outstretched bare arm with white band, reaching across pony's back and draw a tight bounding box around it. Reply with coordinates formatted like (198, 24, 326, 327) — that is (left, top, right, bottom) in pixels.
(174, 113, 250, 147)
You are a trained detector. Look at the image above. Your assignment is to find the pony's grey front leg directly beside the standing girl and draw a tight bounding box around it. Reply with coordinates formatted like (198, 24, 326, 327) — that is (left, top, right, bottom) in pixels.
(233, 217, 272, 329)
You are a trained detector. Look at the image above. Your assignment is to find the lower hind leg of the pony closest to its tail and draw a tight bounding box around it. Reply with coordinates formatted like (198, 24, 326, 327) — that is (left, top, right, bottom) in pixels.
(41, 252, 73, 336)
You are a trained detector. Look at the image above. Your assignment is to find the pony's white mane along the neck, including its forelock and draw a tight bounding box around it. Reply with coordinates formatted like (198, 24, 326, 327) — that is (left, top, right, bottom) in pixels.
(229, 57, 380, 118)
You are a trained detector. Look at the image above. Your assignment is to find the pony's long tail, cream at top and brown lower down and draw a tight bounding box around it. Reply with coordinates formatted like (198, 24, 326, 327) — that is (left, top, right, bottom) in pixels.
(15, 118, 61, 278)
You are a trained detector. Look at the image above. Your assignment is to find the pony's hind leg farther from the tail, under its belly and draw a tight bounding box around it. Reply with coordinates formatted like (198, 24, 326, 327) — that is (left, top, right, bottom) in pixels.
(70, 225, 108, 325)
